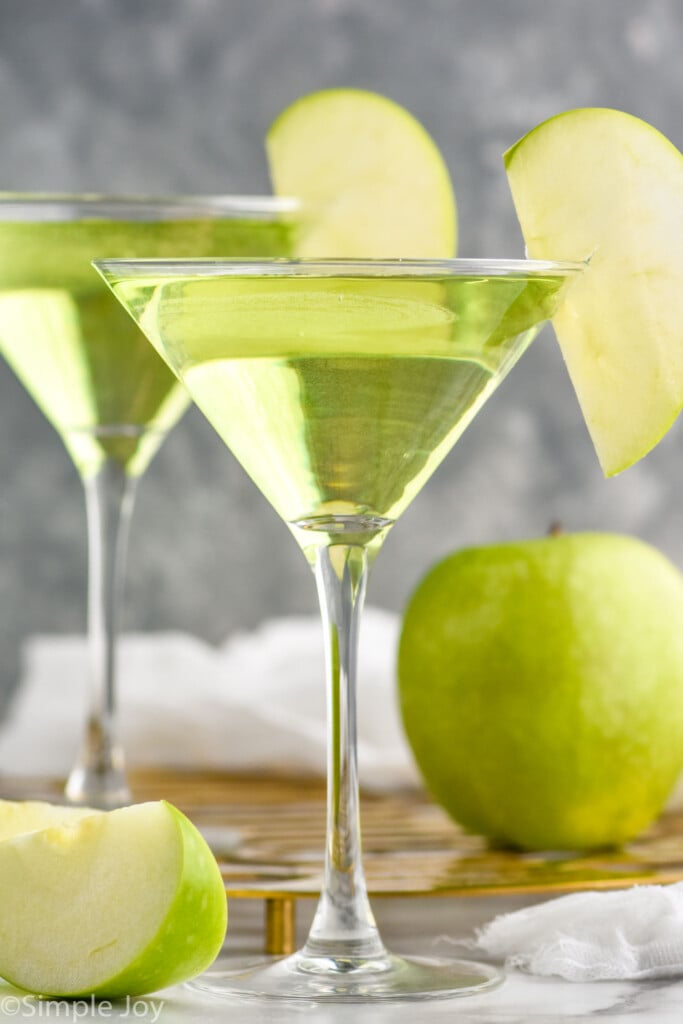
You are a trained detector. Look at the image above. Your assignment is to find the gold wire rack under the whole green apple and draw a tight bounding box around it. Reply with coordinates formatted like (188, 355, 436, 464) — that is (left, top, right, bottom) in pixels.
(5, 771, 683, 953)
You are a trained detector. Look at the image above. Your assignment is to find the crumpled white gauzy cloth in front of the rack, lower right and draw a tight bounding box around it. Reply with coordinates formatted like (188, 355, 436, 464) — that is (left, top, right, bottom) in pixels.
(473, 882, 683, 981)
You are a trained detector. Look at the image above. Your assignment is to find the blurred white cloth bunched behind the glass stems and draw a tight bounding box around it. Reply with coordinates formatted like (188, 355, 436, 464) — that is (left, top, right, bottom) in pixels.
(0, 607, 417, 790)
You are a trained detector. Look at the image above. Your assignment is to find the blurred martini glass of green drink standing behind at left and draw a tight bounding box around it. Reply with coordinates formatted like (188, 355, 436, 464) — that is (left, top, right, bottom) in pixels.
(0, 194, 293, 808)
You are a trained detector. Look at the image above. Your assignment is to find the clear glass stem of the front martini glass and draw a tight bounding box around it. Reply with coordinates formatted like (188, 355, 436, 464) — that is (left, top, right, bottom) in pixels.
(302, 544, 386, 963)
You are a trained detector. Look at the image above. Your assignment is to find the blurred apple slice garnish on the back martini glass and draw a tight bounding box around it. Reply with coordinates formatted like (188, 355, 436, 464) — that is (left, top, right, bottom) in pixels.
(266, 89, 457, 258)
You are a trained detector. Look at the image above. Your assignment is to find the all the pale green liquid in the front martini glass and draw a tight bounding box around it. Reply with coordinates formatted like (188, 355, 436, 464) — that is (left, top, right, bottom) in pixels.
(114, 276, 562, 531)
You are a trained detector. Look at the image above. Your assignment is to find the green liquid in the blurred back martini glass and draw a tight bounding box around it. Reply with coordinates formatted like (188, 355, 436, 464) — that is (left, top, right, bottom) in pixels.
(0, 220, 288, 476)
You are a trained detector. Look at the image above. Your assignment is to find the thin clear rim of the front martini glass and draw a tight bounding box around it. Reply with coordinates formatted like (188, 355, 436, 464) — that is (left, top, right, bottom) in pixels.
(91, 257, 589, 278)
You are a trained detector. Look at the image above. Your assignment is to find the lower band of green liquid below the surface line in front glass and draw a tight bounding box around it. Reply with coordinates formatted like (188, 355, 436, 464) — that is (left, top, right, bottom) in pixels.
(183, 356, 494, 526)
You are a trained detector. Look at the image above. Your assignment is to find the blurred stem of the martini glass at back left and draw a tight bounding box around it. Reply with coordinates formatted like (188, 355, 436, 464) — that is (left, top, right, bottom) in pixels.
(66, 459, 136, 808)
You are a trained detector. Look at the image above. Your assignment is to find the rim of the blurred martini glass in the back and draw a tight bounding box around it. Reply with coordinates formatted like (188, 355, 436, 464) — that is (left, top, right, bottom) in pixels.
(0, 190, 301, 221)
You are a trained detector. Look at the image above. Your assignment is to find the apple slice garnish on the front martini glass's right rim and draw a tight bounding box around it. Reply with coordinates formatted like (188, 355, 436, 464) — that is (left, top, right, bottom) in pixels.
(505, 109, 683, 476)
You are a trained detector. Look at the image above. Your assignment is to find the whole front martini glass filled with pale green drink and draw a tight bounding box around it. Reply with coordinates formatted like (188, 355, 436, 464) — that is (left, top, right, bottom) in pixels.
(95, 260, 581, 1000)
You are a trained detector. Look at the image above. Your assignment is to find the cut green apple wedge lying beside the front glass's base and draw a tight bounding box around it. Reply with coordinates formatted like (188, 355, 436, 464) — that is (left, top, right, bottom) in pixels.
(0, 801, 227, 998)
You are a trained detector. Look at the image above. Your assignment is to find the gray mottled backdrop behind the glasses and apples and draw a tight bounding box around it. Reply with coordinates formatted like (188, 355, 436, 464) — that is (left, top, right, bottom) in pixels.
(0, 0, 683, 712)
